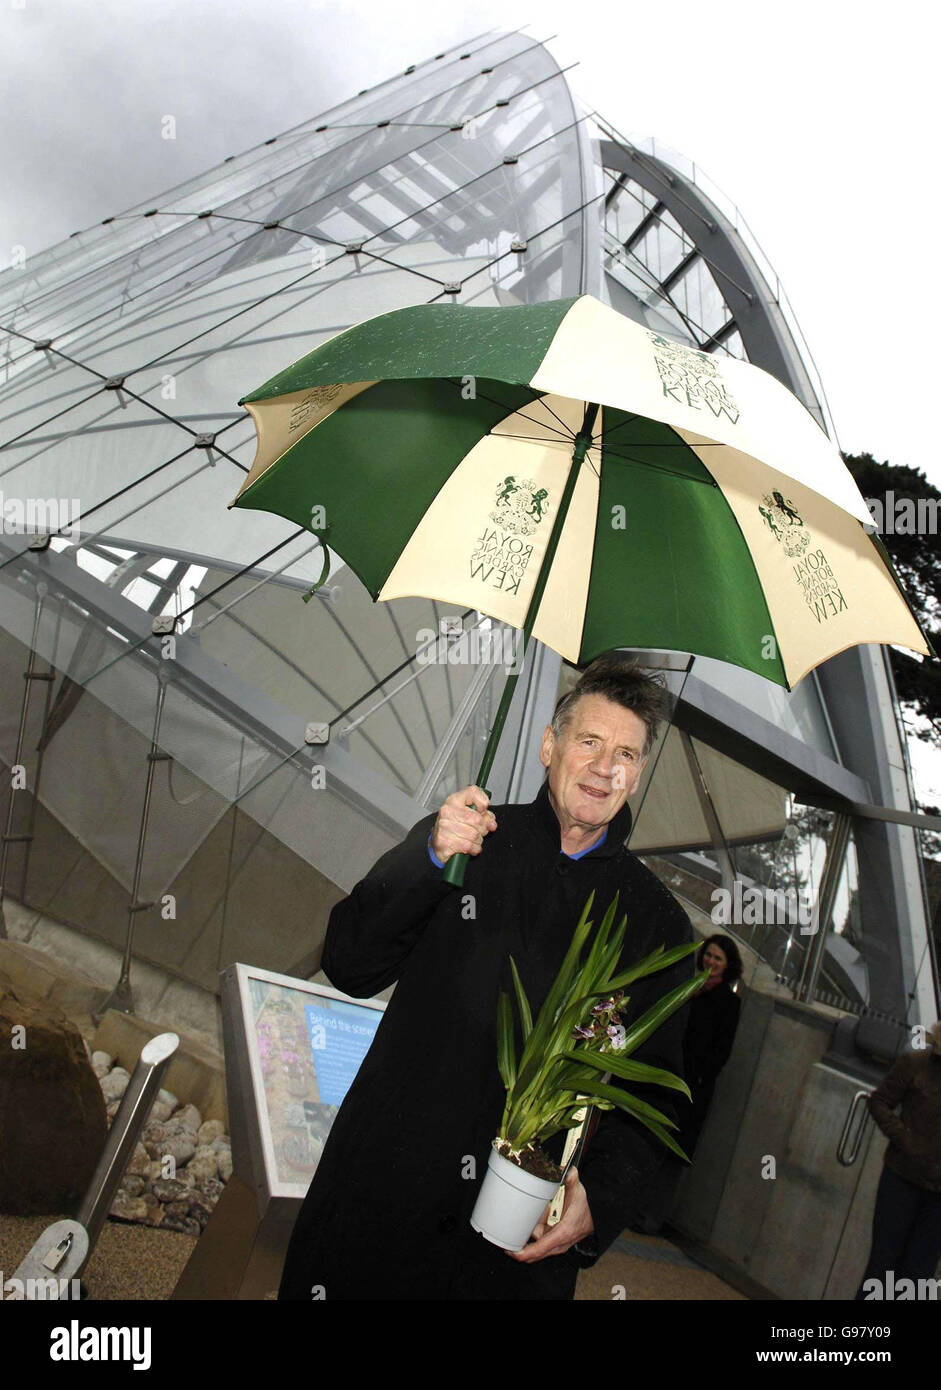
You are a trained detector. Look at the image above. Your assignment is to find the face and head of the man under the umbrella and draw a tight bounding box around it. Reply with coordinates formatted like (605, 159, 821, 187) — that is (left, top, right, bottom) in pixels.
(539, 695, 646, 831)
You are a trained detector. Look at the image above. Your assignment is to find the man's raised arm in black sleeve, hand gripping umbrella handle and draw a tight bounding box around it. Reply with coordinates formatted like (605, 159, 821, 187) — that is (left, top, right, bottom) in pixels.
(321, 787, 496, 998)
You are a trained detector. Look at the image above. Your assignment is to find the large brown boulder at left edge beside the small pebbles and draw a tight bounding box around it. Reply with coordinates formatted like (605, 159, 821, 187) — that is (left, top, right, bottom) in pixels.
(0, 973, 107, 1216)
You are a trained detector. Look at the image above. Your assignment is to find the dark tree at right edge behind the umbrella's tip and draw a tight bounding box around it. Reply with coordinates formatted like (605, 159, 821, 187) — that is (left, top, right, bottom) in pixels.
(844, 453, 941, 746)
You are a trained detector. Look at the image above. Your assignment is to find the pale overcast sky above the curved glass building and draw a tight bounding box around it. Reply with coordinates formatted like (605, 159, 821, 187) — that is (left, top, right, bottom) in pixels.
(0, 0, 941, 806)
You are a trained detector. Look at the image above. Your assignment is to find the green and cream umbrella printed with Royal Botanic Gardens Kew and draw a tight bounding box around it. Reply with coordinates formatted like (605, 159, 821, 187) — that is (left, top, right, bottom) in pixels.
(231, 295, 930, 881)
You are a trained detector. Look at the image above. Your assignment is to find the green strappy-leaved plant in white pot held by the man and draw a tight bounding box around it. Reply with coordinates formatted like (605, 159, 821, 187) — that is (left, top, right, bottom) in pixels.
(470, 892, 707, 1250)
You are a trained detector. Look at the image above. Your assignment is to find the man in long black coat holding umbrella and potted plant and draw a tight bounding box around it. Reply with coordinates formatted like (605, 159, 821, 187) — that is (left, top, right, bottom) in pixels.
(279, 656, 692, 1300)
